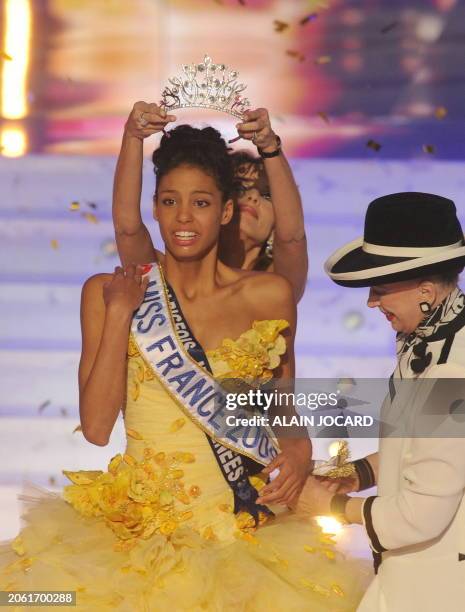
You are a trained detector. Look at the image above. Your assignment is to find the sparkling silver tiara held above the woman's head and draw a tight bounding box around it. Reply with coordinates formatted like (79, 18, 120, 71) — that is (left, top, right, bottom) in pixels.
(160, 55, 250, 119)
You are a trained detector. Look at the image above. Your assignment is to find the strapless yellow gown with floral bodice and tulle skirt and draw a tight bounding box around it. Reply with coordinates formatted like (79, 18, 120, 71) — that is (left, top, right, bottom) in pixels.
(0, 321, 371, 612)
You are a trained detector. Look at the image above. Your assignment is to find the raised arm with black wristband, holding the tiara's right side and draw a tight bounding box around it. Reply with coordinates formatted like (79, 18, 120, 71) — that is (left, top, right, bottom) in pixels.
(238, 108, 308, 302)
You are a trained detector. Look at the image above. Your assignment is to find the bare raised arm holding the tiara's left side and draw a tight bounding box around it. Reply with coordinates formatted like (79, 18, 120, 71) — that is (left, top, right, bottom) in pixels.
(113, 102, 175, 266)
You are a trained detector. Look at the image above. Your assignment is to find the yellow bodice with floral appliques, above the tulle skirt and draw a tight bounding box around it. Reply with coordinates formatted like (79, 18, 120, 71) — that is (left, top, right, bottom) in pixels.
(64, 320, 288, 547)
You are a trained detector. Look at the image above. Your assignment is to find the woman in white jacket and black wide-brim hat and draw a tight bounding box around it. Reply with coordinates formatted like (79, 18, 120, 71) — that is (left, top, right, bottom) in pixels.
(286, 193, 465, 612)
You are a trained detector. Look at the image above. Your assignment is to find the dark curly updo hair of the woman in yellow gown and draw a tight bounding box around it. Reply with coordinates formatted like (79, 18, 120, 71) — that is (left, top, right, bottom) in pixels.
(152, 125, 234, 202)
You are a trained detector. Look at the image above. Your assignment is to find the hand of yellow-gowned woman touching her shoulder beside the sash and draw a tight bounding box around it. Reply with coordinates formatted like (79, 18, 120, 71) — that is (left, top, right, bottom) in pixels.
(103, 264, 149, 314)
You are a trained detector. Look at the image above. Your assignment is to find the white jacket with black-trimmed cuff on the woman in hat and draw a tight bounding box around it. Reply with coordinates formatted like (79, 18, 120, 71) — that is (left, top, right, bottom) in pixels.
(357, 356, 465, 612)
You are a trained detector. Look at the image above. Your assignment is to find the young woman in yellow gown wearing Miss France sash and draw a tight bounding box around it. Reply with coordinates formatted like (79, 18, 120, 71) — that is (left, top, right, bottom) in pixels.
(0, 126, 368, 612)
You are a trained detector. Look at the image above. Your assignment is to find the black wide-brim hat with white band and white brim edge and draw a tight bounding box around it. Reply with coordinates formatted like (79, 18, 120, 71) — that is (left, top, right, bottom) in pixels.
(325, 192, 465, 287)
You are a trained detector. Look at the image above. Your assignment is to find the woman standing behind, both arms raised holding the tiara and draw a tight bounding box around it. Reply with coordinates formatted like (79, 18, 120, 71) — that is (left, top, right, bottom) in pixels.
(113, 102, 308, 301)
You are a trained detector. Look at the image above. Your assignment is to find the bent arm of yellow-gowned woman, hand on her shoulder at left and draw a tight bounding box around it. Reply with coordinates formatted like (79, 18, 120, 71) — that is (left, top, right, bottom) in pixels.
(79, 266, 147, 446)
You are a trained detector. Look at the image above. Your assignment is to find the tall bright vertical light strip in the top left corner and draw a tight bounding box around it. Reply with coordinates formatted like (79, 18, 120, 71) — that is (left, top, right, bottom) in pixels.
(1, 0, 31, 119)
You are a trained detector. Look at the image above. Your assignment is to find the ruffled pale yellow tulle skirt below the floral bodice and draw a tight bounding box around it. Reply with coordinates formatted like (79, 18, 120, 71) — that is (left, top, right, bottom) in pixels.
(0, 492, 371, 612)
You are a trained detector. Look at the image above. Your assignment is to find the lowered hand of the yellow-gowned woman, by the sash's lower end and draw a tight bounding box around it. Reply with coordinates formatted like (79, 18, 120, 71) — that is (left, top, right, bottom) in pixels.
(257, 440, 311, 505)
